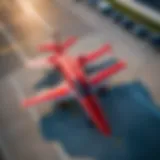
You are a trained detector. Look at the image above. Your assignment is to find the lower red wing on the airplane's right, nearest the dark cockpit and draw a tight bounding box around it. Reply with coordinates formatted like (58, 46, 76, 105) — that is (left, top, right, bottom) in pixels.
(91, 61, 126, 85)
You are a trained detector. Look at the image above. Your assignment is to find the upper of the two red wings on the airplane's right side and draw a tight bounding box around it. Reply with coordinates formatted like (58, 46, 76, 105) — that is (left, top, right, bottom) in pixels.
(79, 44, 111, 66)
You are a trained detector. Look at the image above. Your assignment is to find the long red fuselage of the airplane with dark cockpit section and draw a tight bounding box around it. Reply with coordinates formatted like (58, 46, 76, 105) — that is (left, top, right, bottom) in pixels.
(56, 56, 111, 135)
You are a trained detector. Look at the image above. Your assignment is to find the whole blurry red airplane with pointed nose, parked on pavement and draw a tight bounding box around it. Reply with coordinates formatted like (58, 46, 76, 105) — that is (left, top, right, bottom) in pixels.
(23, 37, 126, 135)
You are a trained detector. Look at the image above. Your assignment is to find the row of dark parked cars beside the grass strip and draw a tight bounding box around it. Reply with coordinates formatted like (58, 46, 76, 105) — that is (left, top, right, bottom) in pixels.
(79, 0, 160, 48)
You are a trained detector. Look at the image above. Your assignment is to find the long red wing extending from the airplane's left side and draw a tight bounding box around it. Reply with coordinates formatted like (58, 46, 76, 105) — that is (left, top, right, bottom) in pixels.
(22, 83, 71, 108)
